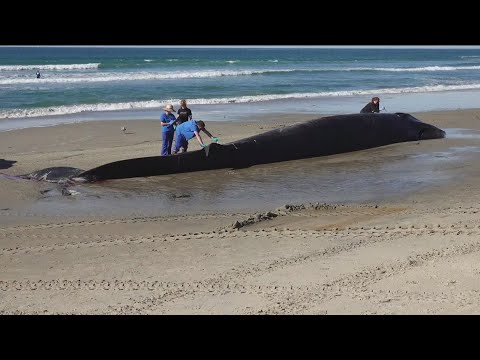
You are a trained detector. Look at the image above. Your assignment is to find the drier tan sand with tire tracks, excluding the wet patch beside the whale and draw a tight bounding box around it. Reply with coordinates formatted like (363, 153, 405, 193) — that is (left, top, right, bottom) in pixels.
(0, 110, 480, 314)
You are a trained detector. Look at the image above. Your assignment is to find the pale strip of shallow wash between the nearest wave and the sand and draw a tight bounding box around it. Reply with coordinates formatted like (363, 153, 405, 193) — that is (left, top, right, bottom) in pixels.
(0, 90, 480, 132)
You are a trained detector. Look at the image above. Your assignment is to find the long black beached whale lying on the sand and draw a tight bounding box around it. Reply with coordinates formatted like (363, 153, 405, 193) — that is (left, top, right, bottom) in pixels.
(21, 113, 445, 182)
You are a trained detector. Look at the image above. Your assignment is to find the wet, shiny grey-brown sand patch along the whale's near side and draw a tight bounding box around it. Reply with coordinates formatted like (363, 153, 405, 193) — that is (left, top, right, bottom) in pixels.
(31, 128, 480, 216)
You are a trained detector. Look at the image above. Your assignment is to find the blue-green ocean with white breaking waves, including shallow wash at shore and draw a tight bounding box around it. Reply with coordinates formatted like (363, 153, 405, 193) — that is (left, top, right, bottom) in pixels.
(0, 46, 480, 131)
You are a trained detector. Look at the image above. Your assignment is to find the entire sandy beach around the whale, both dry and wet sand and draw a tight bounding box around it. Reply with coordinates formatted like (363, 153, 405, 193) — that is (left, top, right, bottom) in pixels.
(0, 109, 480, 314)
